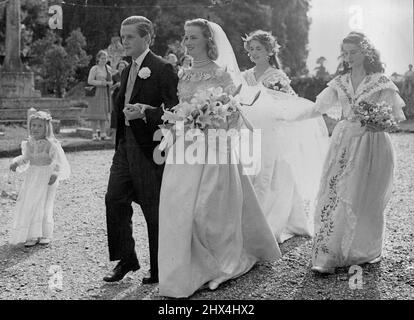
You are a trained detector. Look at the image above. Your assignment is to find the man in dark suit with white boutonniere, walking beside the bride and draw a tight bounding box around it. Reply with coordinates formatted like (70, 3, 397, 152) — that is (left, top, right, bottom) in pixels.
(104, 16, 178, 284)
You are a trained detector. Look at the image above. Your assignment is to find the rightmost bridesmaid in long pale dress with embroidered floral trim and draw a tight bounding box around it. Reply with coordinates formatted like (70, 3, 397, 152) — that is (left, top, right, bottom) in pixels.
(306, 32, 405, 273)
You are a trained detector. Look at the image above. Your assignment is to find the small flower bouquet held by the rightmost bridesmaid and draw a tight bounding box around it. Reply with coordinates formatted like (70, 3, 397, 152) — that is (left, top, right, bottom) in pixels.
(353, 101, 398, 131)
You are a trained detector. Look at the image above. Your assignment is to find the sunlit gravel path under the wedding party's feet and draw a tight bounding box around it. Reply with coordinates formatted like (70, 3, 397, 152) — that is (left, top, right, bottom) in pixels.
(0, 134, 414, 300)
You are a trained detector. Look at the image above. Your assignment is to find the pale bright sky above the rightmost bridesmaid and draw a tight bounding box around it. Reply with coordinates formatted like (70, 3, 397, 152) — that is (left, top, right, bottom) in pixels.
(307, 0, 414, 75)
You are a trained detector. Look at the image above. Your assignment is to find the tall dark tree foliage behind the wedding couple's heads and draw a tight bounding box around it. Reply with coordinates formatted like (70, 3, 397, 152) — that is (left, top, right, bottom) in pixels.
(0, 0, 310, 79)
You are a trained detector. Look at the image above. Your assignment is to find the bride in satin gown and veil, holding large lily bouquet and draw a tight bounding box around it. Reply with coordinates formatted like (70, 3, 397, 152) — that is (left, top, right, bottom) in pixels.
(158, 19, 281, 298)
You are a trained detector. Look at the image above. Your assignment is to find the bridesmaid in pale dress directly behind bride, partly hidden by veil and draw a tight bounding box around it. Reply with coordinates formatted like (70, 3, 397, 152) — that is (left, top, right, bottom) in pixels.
(239, 30, 329, 243)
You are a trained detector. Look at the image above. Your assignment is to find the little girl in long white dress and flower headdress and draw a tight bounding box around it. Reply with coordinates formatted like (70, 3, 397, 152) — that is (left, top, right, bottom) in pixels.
(10, 109, 70, 247)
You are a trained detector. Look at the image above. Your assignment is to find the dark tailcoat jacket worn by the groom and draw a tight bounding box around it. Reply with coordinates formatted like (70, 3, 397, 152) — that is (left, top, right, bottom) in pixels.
(115, 51, 178, 160)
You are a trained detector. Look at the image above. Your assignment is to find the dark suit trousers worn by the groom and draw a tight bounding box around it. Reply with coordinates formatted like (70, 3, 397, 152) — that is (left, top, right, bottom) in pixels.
(105, 127, 164, 275)
